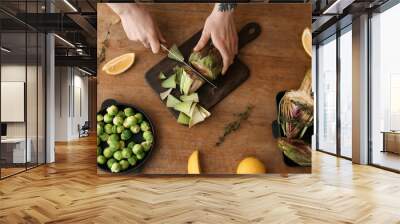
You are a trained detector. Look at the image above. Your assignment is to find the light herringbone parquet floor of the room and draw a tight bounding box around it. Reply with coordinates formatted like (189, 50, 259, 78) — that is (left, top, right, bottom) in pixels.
(0, 138, 400, 224)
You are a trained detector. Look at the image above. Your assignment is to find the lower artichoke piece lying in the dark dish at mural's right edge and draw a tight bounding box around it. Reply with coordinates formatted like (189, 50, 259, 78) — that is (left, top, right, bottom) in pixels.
(278, 138, 311, 166)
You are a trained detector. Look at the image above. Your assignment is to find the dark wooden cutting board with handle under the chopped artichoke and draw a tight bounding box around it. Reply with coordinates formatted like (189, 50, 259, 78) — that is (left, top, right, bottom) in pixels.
(146, 23, 261, 117)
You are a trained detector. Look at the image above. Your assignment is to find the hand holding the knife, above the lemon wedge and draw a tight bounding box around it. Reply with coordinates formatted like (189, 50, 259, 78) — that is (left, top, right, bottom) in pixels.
(108, 3, 166, 53)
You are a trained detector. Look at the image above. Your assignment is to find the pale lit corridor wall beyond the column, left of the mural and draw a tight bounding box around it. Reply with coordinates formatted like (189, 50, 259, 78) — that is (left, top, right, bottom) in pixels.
(55, 67, 89, 141)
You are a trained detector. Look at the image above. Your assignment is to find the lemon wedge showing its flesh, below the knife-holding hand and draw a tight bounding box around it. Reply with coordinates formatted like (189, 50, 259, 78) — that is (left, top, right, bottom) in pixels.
(102, 53, 135, 75)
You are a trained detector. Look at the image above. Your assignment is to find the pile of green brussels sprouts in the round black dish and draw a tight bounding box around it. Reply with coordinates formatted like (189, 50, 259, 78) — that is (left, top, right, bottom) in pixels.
(97, 105, 154, 173)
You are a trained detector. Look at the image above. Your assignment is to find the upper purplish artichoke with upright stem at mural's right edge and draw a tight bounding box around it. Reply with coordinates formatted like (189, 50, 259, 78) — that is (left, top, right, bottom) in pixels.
(278, 70, 314, 138)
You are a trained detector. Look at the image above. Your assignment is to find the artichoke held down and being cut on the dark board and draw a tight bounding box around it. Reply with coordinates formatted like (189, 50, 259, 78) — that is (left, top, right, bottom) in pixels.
(189, 44, 223, 80)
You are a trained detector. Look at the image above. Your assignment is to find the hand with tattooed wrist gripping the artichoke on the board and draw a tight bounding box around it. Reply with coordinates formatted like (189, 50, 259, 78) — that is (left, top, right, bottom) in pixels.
(193, 4, 238, 74)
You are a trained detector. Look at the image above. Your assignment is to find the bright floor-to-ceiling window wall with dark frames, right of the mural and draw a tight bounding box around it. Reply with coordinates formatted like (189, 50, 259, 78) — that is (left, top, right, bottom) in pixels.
(313, 1, 400, 172)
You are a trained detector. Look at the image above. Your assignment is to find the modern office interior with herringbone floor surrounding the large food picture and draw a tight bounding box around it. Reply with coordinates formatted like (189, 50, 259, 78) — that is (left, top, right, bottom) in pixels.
(0, 0, 400, 223)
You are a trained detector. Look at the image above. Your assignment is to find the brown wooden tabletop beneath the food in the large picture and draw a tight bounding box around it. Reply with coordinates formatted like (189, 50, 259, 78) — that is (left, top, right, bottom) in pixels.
(97, 3, 311, 174)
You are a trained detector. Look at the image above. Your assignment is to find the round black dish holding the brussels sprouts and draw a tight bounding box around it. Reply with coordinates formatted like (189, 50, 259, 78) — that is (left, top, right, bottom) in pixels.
(96, 99, 156, 174)
